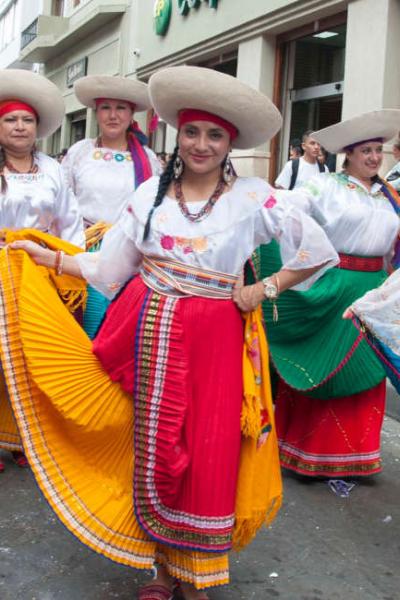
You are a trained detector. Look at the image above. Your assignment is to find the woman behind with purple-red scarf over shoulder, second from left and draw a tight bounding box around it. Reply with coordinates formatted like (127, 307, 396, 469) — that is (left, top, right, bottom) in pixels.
(62, 75, 162, 338)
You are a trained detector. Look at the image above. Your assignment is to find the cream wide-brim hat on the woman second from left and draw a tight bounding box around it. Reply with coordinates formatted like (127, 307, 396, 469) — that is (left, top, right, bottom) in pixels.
(74, 75, 151, 112)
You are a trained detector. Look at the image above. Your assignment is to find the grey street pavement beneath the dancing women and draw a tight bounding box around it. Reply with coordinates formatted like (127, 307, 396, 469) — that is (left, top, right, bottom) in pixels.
(0, 417, 400, 600)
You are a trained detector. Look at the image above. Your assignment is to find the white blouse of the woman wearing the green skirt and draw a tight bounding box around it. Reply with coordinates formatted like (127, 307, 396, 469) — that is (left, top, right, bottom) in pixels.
(276, 173, 400, 261)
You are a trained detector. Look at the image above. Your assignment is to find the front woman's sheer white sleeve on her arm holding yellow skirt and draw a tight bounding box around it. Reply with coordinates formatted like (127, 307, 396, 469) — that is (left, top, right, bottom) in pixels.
(76, 205, 143, 299)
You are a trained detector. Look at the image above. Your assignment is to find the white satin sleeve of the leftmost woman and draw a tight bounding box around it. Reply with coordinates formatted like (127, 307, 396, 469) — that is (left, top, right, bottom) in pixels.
(51, 163, 85, 248)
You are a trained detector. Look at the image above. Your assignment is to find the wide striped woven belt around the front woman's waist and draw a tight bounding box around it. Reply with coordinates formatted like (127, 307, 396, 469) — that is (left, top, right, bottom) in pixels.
(140, 257, 237, 300)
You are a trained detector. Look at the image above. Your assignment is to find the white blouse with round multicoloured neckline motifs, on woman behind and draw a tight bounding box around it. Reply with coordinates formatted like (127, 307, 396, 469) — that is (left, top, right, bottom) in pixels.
(62, 139, 161, 224)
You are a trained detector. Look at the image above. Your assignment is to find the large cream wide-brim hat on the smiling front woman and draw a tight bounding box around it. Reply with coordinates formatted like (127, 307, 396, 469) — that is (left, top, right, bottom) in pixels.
(149, 67, 282, 149)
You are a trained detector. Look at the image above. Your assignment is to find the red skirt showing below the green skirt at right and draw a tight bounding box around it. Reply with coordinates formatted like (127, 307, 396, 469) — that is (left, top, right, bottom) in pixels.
(275, 380, 386, 478)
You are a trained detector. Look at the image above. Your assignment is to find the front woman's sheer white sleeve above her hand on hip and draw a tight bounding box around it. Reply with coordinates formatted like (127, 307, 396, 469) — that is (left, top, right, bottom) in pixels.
(257, 188, 339, 290)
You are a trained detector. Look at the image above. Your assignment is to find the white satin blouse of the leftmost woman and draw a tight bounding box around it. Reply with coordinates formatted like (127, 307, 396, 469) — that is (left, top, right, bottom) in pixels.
(0, 152, 85, 248)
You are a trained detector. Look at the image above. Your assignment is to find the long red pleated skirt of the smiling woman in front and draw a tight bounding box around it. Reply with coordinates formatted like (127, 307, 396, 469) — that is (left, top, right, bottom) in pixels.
(93, 276, 243, 552)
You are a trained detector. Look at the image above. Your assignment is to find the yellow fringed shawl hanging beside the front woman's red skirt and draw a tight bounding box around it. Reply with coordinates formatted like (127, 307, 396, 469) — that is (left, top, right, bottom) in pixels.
(233, 307, 282, 550)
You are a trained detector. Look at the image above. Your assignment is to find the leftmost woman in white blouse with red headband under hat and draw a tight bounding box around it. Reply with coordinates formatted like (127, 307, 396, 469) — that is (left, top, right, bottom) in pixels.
(0, 69, 84, 472)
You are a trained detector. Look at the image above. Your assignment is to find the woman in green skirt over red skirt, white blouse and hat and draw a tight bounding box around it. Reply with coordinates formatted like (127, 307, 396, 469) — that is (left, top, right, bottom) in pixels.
(261, 110, 400, 477)
